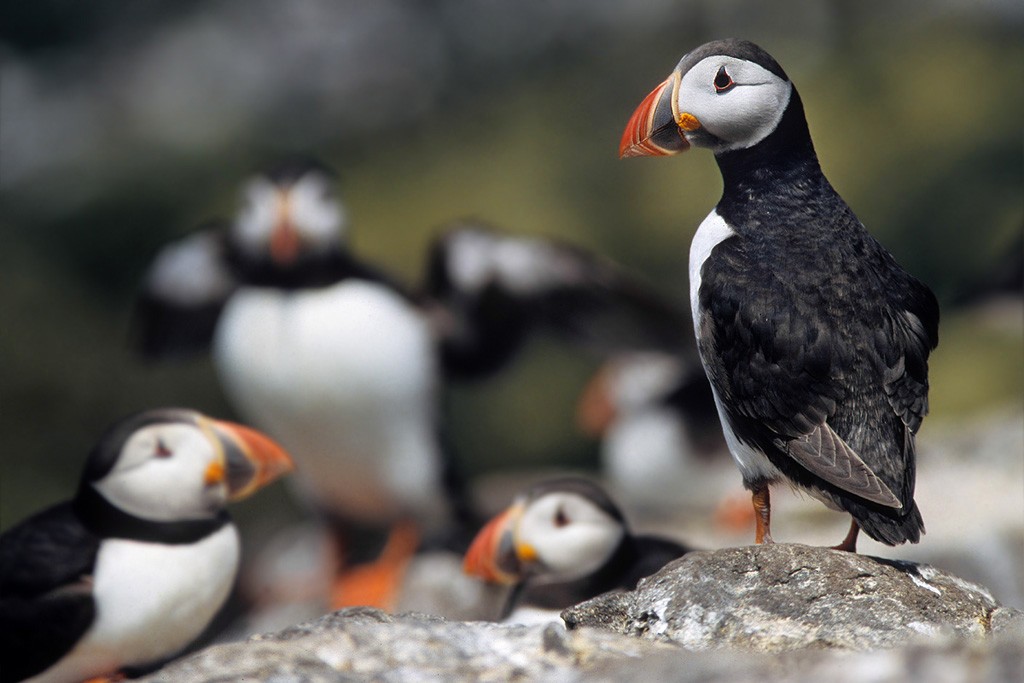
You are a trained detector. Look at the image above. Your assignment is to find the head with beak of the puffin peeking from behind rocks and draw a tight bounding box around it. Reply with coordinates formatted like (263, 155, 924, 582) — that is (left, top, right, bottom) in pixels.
(463, 477, 628, 585)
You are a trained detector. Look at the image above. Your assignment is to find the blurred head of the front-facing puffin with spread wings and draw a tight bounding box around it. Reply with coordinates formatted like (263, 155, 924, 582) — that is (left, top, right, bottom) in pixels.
(230, 160, 347, 270)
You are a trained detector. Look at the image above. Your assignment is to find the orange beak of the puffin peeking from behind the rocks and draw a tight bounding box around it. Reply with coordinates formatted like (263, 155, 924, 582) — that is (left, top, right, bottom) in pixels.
(462, 503, 537, 586)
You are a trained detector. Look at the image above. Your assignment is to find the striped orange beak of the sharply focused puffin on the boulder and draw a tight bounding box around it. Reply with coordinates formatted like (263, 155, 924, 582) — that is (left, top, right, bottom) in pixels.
(618, 71, 699, 159)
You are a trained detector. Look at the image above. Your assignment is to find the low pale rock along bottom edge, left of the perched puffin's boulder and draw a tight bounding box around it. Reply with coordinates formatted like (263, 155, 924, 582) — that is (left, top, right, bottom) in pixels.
(144, 608, 676, 683)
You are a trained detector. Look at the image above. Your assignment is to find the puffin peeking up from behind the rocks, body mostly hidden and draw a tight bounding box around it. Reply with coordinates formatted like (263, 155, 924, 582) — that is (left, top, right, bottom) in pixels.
(463, 476, 690, 623)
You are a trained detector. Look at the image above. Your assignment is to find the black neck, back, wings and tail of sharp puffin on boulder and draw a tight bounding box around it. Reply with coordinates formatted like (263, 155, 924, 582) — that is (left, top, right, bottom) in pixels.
(698, 62, 939, 545)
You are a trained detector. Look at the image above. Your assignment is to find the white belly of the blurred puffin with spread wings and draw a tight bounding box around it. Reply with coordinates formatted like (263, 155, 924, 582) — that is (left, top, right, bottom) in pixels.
(214, 281, 439, 519)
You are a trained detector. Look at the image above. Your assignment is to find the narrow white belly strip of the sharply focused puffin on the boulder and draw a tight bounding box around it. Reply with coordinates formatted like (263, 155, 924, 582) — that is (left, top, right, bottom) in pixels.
(689, 211, 782, 480)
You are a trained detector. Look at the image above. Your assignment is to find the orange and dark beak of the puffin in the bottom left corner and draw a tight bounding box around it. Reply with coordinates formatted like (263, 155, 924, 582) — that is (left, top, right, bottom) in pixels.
(204, 420, 295, 502)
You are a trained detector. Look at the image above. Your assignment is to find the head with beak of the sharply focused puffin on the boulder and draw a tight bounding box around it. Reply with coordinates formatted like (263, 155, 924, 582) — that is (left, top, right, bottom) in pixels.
(618, 40, 795, 157)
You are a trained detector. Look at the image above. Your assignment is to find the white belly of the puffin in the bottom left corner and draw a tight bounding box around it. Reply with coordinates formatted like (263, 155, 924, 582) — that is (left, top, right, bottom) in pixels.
(30, 524, 240, 683)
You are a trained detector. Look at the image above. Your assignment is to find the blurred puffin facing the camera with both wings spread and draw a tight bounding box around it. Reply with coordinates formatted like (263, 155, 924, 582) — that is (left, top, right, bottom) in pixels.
(137, 162, 688, 607)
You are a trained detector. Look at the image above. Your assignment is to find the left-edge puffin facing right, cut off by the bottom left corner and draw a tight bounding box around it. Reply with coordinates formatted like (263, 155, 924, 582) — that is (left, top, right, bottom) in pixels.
(0, 409, 292, 683)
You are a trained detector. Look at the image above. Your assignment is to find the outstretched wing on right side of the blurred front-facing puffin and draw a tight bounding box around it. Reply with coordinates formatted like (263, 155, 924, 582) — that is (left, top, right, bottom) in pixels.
(421, 219, 693, 381)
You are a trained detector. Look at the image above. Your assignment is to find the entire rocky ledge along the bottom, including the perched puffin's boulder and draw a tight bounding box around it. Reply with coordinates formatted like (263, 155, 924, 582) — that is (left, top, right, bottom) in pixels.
(146, 545, 1024, 683)
